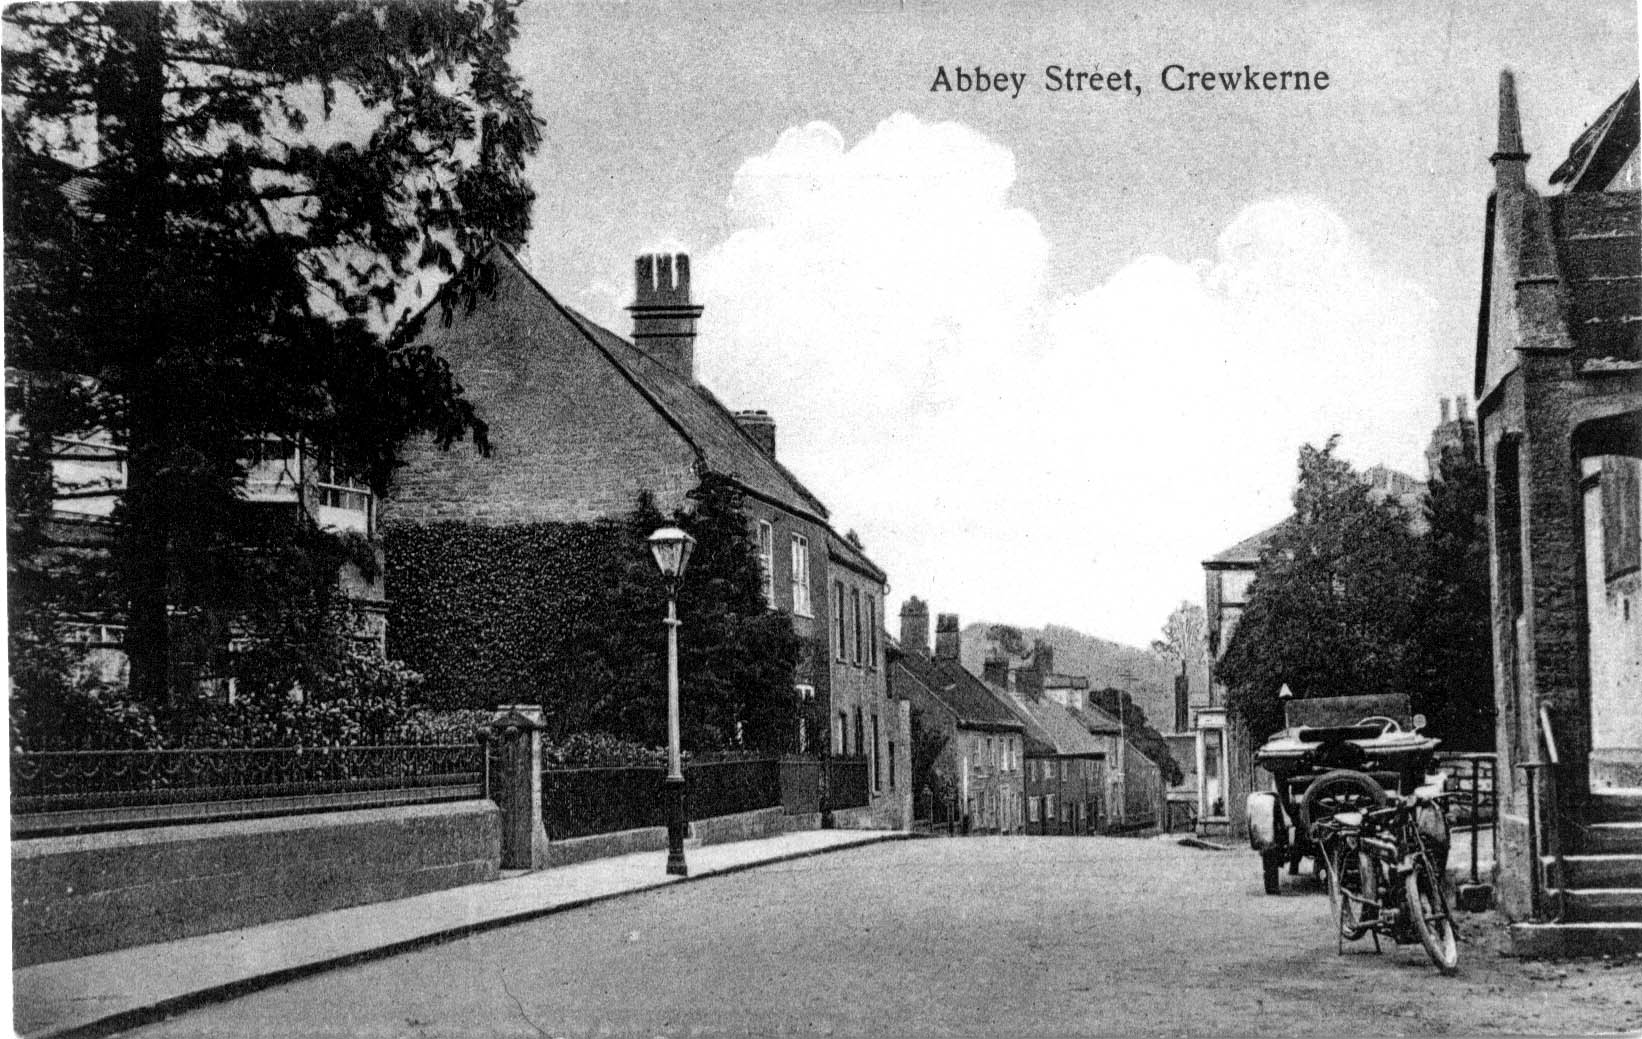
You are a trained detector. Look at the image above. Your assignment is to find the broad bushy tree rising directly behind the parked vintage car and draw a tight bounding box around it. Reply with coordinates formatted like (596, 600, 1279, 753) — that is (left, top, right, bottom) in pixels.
(1215, 437, 1422, 734)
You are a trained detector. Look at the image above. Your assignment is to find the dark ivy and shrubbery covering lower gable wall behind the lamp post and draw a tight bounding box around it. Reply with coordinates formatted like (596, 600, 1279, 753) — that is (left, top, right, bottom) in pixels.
(386, 473, 800, 750)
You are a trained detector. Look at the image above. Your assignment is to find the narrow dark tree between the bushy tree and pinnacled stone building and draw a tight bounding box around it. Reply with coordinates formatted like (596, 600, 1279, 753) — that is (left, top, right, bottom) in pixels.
(1409, 445, 1494, 750)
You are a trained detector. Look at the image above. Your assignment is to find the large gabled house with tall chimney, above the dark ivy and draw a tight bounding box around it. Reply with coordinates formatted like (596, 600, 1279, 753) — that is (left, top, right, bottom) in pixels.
(383, 248, 906, 814)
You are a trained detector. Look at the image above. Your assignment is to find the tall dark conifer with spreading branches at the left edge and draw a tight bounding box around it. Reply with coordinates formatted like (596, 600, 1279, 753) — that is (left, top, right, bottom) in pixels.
(3, 0, 539, 703)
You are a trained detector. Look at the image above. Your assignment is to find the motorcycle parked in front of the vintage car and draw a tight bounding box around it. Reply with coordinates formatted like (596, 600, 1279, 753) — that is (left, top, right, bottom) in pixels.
(1310, 774, 1460, 975)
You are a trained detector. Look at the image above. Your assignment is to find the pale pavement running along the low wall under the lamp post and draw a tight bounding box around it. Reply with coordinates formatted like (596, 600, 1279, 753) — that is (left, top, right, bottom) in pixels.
(11, 831, 910, 1039)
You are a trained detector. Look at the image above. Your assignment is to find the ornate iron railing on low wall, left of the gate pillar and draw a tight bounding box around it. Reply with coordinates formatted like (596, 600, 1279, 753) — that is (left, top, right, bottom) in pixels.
(11, 744, 484, 835)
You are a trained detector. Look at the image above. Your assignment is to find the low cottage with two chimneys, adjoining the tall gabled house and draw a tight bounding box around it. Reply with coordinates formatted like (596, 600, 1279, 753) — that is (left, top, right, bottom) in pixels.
(888, 596, 1026, 834)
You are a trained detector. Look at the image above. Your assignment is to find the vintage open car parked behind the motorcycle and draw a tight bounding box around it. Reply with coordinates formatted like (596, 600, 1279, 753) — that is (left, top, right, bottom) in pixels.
(1248, 688, 1440, 895)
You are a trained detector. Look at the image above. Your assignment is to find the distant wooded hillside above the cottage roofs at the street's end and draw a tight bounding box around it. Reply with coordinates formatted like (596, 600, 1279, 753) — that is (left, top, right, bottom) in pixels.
(962, 620, 1207, 732)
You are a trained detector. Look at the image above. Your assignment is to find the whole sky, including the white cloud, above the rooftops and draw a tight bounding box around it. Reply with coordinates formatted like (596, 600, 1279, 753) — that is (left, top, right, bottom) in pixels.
(514, 0, 1637, 645)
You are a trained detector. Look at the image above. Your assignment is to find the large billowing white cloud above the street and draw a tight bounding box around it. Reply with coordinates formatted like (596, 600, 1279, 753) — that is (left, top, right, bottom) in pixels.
(696, 113, 1433, 642)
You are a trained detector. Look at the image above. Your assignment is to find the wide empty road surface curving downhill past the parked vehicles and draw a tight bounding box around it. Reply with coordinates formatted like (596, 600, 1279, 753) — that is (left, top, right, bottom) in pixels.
(124, 837, 1642, 1037)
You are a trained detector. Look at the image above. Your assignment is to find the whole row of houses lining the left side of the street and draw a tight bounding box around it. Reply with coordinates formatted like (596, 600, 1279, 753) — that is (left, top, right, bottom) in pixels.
(7, 236, 1161, 832)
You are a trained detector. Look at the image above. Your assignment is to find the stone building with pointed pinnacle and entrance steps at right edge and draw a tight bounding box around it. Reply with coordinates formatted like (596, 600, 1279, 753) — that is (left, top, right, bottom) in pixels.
(1475, 72, 1642, 952)
